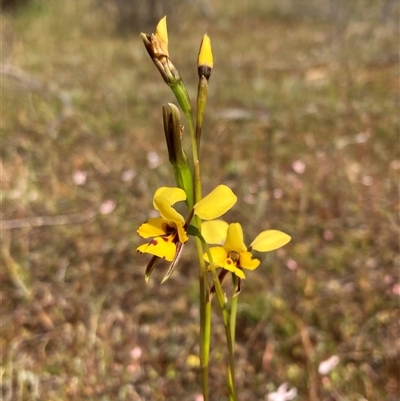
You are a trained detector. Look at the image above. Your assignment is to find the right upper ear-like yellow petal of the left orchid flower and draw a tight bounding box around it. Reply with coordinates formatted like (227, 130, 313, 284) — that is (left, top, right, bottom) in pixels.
(194, 185, 237, 220)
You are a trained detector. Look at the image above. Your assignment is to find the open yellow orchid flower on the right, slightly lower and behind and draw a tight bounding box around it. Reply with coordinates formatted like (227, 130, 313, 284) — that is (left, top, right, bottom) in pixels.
(201, 220, 291, 285)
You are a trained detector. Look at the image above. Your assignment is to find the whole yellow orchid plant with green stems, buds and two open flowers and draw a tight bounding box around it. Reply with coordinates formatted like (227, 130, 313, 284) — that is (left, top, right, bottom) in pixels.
(137, 17, 290, 401)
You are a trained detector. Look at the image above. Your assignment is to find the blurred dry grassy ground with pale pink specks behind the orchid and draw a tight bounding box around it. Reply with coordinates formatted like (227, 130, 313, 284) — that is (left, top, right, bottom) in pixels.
(0, 0, 400, 401)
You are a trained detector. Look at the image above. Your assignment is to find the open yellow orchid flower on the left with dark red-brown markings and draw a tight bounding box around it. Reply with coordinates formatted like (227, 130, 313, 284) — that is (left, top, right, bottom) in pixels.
(137, 185, 237, 282)
